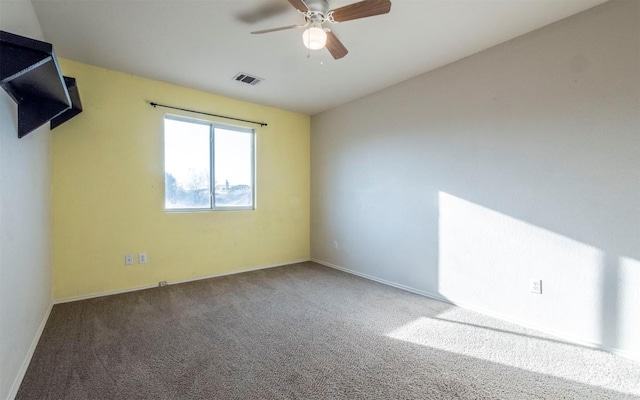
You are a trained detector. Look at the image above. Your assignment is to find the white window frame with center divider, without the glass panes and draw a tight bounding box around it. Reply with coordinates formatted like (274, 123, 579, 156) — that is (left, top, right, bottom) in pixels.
(162, 114, 256, 213)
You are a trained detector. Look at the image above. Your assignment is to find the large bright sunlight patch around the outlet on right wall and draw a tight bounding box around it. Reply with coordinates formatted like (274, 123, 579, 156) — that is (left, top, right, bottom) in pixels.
(438, 192, 607, 343)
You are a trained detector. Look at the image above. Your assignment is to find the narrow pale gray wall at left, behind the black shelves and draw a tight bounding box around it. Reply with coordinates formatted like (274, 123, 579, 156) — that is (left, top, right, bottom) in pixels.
(0, 0, 51, 399)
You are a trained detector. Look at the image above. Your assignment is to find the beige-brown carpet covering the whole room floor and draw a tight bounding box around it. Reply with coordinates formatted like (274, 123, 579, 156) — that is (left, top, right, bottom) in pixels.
(17, 263, 640, 400)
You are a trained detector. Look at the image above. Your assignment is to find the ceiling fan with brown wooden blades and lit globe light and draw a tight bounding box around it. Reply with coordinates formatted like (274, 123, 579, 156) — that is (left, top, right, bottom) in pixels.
(251, 0, 391, 60)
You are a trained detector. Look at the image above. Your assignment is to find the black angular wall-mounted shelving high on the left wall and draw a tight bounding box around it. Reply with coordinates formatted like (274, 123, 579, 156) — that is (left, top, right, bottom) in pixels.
(0, 31, 82, 138)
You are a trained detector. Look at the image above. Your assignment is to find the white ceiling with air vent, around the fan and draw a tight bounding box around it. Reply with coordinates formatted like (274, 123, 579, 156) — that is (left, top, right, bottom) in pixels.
(30, 0, 606, 115)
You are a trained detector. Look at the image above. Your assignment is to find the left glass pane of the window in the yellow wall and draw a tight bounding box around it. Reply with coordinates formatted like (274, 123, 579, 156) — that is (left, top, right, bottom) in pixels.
(164, 118, 211, 209)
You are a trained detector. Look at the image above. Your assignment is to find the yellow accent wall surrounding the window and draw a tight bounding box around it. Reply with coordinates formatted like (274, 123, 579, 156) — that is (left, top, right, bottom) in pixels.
(52, 60, 310, 299)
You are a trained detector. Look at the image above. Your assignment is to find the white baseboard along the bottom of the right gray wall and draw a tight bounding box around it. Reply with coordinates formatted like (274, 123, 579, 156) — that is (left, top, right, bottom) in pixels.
(311, 258, 640, 362)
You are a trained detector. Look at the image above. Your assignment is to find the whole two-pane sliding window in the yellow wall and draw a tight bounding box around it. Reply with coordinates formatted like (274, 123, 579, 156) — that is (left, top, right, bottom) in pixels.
(164, 116, 255, 211)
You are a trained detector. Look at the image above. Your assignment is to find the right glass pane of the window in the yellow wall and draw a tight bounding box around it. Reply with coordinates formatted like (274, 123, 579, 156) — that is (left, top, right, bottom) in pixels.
(214, 128, 253, 207)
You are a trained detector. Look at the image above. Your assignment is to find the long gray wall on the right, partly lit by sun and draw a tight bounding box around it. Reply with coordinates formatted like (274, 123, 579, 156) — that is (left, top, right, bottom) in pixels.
(311, 0, 640, 359)
